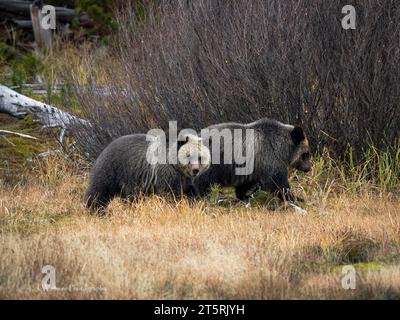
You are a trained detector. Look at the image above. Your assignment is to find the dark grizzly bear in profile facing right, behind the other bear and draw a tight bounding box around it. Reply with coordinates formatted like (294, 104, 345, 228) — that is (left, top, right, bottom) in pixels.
(195, 118, 311, 201)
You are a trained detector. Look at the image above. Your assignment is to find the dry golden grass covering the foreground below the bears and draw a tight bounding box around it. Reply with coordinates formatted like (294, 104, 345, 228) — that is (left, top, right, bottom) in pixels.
(0, 155, 400, 299)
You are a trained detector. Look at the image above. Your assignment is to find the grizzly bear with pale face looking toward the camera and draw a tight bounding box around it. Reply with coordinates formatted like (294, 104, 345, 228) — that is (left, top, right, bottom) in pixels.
(85, 134, 211, 209)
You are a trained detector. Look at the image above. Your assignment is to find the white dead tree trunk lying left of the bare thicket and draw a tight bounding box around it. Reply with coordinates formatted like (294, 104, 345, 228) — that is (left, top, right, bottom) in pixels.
(0, 85, 91, 142)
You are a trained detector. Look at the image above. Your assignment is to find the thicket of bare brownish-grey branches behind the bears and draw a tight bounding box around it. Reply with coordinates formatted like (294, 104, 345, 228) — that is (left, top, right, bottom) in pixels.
(73, 0, 400, 160)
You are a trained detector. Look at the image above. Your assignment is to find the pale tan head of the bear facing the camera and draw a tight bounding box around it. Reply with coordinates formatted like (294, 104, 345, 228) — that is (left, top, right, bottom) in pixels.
(176, 134, 211, 178)
